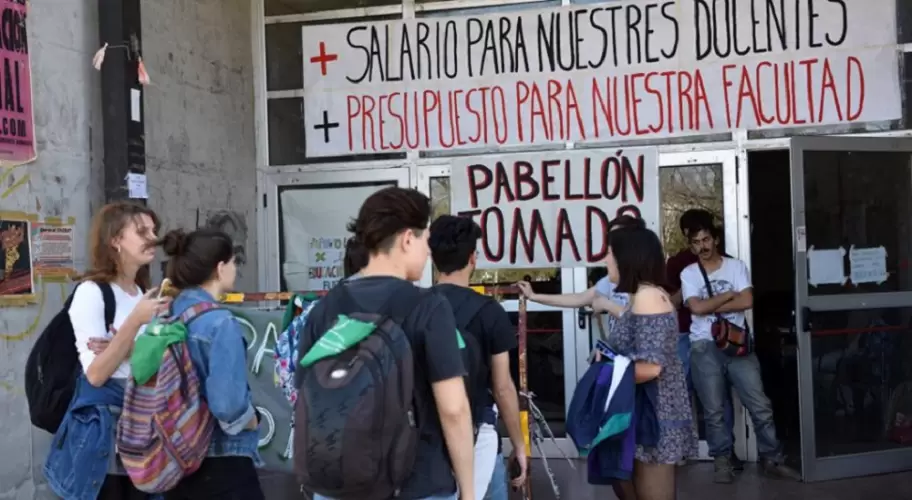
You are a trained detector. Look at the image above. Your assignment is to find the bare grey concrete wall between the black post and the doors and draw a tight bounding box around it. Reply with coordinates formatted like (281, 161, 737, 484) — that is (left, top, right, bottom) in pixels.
(142, 0, 257, 290)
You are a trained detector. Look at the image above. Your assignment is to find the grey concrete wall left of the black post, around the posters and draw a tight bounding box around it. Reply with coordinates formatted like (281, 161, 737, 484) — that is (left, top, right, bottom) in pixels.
(0, 0, 103, 499)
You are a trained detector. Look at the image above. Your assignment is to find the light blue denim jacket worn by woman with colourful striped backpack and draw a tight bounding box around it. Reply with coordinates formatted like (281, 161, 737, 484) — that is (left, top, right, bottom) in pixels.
(171, 288, 264, 467)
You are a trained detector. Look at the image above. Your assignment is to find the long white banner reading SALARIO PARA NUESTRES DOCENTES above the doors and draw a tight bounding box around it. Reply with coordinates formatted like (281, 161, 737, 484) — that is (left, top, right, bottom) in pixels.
(302, 0, 902, 156)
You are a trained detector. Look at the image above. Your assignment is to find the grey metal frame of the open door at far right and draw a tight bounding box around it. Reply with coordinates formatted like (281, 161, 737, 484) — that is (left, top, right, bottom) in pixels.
(789, 136, 912, 481)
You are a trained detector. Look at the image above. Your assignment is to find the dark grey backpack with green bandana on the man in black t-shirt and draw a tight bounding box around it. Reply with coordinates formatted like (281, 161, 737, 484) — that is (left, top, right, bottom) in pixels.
(294, 283, 426, 500)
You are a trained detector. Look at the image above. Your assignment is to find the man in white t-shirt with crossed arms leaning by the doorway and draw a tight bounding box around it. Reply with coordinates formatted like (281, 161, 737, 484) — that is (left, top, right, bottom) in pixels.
(681, 220, 801, 483)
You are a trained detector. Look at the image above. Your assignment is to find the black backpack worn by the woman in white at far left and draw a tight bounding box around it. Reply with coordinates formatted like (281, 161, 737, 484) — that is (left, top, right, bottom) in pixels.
(25, 283, 117, 434)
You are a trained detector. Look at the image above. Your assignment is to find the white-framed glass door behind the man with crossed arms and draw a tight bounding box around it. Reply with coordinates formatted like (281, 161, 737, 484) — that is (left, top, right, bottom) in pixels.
(659, 150, 754, 460)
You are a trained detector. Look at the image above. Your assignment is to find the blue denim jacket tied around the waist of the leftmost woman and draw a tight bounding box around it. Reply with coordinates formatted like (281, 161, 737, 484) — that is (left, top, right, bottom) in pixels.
(44, 375, 124, 500)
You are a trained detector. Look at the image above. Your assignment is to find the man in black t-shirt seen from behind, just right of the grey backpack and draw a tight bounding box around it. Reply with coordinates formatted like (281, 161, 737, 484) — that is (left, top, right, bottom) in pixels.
(429, 215, 528, 498)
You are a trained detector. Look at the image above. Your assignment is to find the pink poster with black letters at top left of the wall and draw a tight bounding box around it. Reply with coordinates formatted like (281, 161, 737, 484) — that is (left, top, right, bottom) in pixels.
(0, 0, 37, 166)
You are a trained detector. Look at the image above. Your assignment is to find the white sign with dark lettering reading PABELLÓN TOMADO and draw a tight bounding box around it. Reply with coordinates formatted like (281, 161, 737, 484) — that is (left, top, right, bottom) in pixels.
(450, 148, 659, 268)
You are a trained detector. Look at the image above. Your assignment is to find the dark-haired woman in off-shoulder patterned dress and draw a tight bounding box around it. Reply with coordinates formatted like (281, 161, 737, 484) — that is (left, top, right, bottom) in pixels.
(595, 227, 697, 500)
